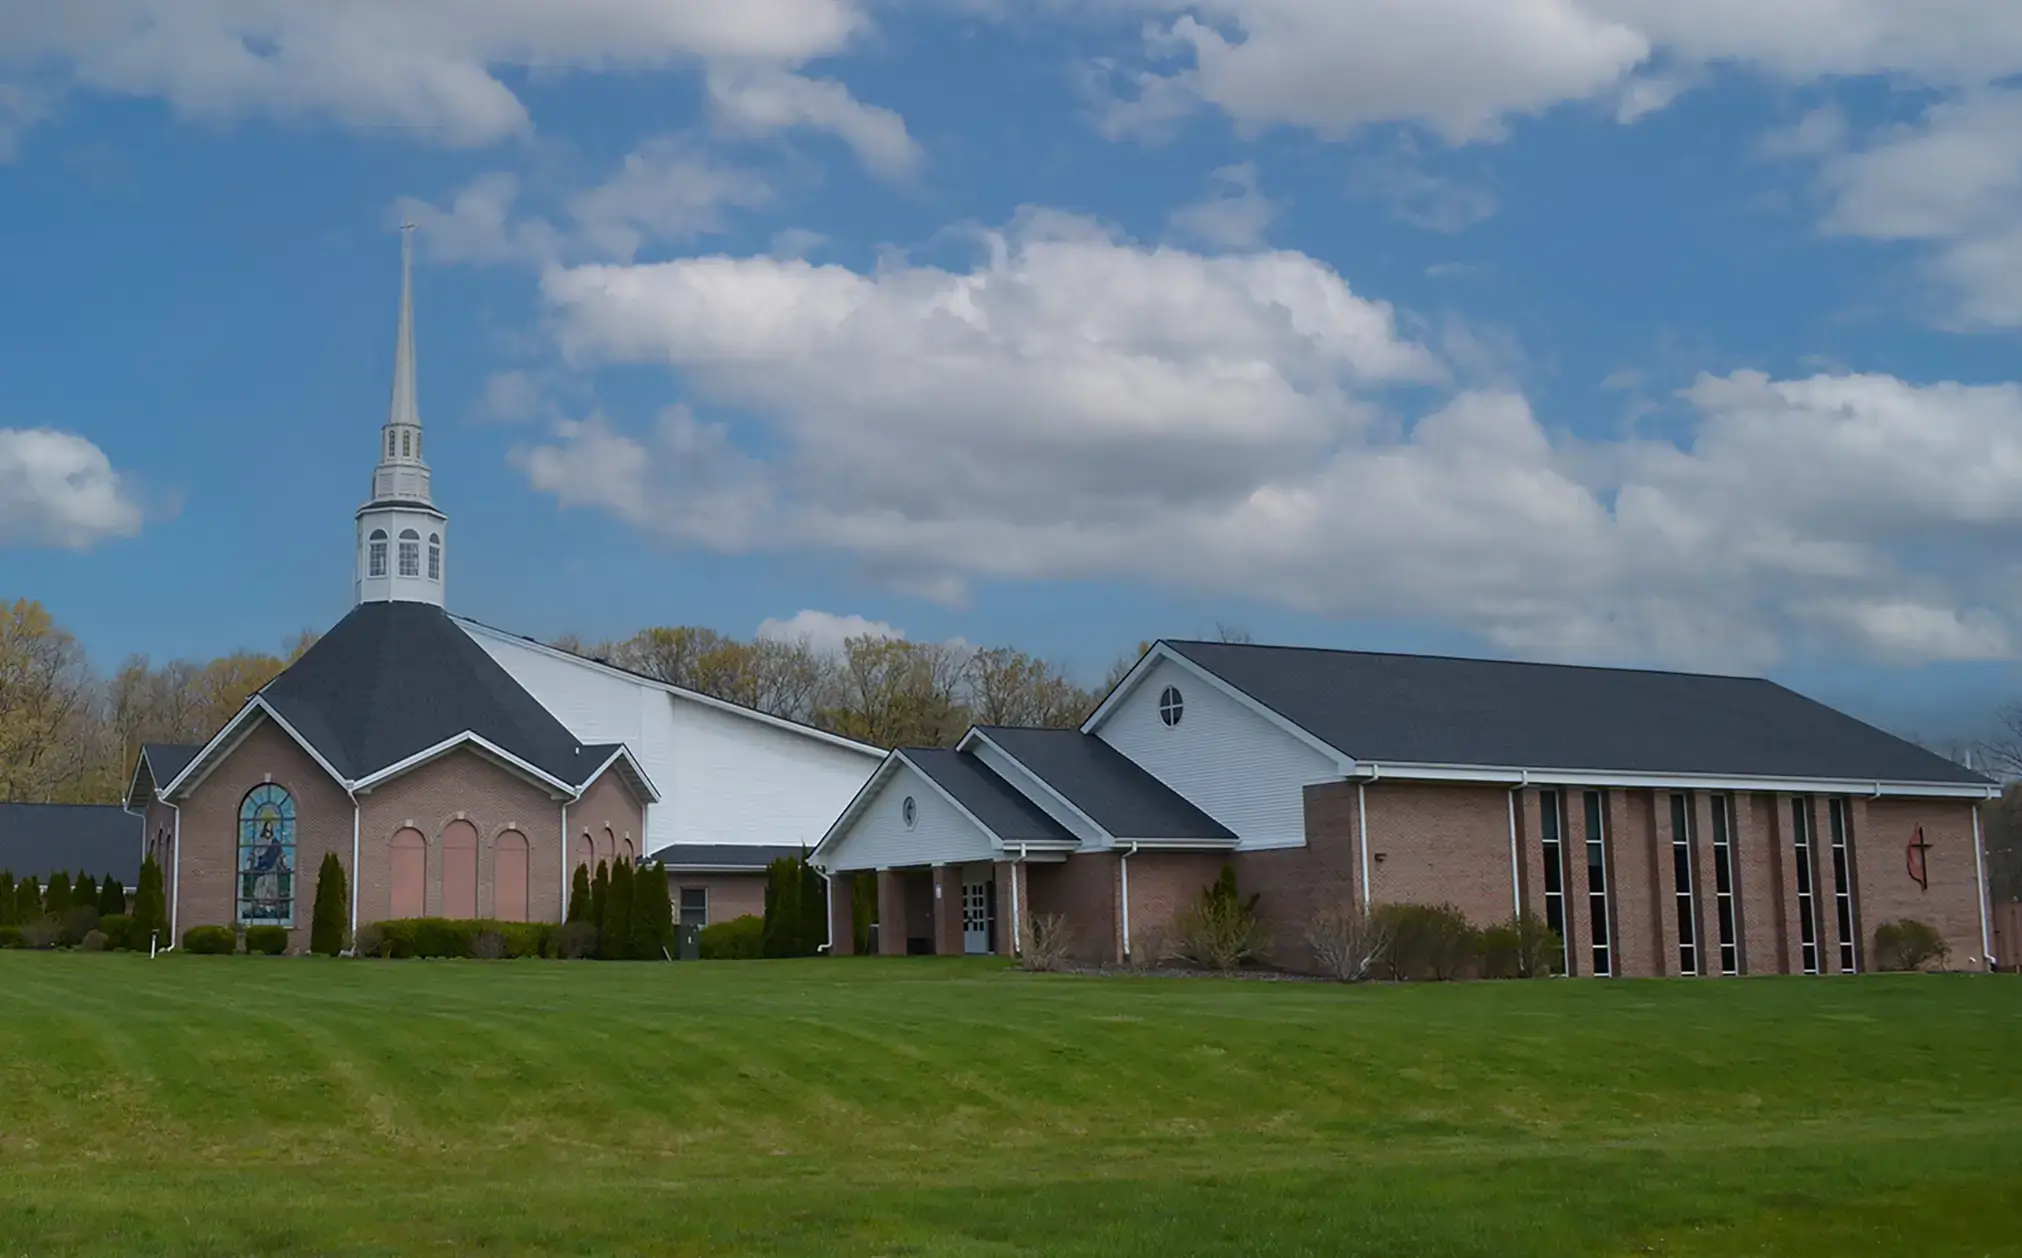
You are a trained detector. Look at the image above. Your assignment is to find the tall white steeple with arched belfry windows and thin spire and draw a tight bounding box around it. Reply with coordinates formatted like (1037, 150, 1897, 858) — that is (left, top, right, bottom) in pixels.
(356, 222, 449, 607)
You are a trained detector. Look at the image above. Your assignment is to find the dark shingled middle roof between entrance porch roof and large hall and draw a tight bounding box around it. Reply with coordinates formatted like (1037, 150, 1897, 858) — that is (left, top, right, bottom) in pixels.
(979, 726, 1235, 841)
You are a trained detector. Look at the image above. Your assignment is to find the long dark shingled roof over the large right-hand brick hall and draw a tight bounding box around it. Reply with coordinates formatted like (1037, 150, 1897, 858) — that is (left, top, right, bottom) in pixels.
(1167, 641, 1988, 785)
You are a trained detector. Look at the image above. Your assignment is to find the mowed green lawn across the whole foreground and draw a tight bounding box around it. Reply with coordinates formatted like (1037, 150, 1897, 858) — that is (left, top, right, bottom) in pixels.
(0, 953, 2022, 1258)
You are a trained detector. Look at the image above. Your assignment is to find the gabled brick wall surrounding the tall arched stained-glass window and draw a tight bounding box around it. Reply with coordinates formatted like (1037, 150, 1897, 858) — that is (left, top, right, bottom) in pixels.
(172, 718, 352, 951)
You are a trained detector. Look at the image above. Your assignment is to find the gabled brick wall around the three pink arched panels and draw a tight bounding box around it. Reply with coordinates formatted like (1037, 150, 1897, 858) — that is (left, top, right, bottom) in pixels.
(359, 750, 574, 938)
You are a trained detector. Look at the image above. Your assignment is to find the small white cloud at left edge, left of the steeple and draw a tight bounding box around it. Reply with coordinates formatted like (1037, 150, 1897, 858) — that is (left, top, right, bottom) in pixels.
(0, 429, 142, 550)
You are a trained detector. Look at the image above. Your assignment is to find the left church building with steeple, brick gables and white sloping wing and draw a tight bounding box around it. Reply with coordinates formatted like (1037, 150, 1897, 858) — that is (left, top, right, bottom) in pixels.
(125, 231, 882, 951)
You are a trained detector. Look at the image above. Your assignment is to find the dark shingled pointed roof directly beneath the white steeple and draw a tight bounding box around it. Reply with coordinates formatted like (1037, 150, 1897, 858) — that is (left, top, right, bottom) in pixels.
(261, 603, 594, 785)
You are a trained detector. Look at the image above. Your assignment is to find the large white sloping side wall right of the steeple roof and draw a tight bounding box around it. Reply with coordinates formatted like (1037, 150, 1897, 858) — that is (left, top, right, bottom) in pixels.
(471, 629, 878, 851)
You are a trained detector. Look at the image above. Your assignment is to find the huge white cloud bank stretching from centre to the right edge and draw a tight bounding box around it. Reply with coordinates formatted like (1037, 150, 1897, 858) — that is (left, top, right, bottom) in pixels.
(501, 214, 2022, 665)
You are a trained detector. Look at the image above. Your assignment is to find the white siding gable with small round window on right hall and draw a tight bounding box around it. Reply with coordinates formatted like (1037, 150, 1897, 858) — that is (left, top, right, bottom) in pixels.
(1094, 659, 1341, 847)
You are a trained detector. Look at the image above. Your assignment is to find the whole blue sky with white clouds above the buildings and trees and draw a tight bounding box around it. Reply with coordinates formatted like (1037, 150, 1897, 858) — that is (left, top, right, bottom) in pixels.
(0, 0, 2022, 734)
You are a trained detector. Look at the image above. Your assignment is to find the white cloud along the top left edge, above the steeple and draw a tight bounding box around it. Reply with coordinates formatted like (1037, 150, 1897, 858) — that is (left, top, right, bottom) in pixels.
(0, 0, 910, 174)
